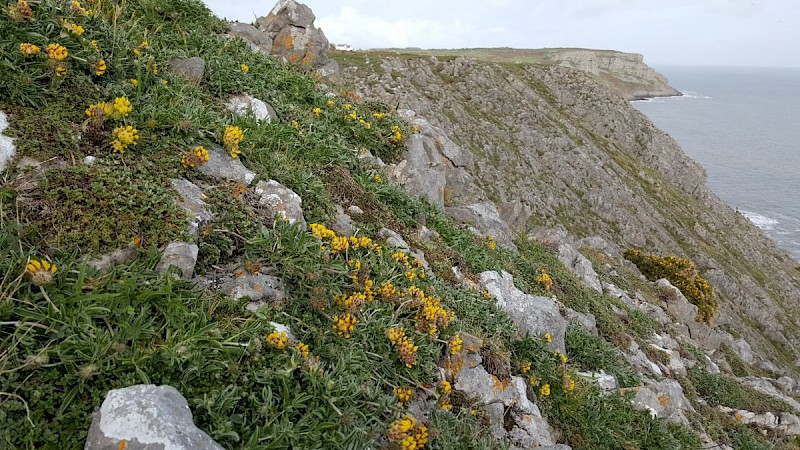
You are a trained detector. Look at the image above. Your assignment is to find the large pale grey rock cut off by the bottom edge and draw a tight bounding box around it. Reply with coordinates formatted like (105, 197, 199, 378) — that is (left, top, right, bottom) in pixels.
(84, 384, 223, 450)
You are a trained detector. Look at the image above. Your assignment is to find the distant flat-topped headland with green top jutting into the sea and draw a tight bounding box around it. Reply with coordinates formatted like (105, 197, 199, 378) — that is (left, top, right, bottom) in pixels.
(368, 48, 681, 100)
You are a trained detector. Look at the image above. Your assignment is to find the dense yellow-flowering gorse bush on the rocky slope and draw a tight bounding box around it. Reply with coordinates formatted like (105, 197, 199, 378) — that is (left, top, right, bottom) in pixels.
(624, 249, 719, 323)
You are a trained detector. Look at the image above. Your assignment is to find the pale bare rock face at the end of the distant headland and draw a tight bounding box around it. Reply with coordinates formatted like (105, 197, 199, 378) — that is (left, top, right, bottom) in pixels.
(547, 49, 681, 100)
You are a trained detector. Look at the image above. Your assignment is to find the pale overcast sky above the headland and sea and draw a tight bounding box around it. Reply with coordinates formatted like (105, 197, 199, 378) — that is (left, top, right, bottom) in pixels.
(204, 0, 800, 67)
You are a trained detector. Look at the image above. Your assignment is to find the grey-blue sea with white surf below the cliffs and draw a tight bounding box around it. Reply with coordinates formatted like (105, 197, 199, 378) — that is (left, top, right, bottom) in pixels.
(632, 66, 800, 261)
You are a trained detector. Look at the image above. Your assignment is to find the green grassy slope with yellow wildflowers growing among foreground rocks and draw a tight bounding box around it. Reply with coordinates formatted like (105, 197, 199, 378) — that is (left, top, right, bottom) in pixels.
(0, 0, 792, 449)
